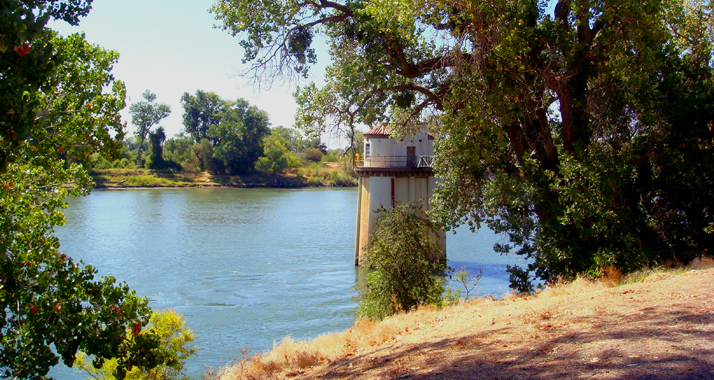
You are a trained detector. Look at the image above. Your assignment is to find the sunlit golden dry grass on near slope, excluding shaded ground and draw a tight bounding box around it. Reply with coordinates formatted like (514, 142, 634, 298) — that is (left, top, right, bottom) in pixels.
(206, 259, 714, 380)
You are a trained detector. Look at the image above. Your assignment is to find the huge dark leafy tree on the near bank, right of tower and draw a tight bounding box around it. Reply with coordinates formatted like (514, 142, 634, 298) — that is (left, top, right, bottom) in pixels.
(212, 0, 714, 290)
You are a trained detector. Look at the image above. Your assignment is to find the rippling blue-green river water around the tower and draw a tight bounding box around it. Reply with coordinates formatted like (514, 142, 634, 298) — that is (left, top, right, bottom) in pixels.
(51, 188, 520, 379)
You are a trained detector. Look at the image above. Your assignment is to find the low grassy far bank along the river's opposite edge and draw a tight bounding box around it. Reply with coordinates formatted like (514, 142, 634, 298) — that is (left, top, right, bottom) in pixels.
(91, 167, 357, 189)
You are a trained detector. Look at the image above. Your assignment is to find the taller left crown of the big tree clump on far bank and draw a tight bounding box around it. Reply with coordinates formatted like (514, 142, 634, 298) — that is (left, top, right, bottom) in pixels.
(181, 90, 230, 145)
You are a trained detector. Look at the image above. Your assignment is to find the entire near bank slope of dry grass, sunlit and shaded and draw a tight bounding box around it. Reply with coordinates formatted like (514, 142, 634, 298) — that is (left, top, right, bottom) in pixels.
(206, 260, 714, 380)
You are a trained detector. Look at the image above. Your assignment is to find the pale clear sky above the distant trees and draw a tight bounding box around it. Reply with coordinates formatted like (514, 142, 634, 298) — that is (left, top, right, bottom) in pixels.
(49, 0, 334, 143)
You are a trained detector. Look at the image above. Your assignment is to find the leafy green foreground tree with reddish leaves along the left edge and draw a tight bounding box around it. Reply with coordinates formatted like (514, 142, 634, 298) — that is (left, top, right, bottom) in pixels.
(0, 25, 161, 379)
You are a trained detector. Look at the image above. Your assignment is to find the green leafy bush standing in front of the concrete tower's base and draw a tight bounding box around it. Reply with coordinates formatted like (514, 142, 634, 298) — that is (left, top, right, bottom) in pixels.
(357, 202, 446, 319)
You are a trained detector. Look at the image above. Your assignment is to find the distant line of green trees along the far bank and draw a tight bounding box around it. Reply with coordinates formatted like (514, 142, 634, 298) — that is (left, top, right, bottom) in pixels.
(90, 90, 340, 175)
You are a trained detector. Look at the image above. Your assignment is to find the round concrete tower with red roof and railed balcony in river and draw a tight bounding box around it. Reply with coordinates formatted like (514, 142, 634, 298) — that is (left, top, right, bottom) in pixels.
(355, 125, 446, 265)
